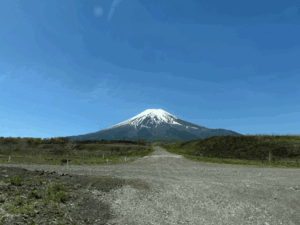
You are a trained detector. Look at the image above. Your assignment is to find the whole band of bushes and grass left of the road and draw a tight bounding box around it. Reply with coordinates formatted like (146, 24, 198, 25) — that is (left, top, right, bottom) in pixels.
(0, 137, 154, 165)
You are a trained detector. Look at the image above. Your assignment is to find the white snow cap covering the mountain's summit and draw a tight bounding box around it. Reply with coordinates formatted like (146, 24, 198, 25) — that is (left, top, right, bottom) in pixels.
(105, 109, 181, 130)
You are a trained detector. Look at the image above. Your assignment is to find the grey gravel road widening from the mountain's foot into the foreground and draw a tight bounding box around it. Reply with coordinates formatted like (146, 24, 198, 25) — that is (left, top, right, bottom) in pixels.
(1, 146, 300, 225)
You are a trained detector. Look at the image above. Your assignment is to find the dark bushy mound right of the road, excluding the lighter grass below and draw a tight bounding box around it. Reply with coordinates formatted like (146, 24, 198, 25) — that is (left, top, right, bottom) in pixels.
(178, 136, 300, 161)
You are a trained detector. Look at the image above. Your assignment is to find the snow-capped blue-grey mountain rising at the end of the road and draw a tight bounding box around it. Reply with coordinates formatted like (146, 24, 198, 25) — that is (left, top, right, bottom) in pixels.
(66, 109, 243, 142)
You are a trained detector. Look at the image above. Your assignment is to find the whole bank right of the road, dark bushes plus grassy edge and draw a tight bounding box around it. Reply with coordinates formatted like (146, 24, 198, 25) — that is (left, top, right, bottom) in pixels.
(152, 135, 300, 168)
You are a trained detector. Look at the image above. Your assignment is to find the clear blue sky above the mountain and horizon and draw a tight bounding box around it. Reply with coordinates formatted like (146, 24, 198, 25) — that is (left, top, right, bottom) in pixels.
(0, 0, 300, 138)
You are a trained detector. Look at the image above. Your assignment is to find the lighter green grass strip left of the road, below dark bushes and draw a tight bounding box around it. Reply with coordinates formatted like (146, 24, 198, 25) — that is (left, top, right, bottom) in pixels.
(0, 146, 154, 165)
